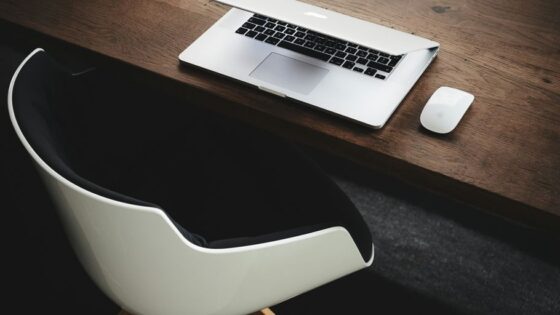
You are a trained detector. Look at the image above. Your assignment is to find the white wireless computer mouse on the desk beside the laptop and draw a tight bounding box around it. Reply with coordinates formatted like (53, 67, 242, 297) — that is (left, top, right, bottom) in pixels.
(420, 86, 474, 134)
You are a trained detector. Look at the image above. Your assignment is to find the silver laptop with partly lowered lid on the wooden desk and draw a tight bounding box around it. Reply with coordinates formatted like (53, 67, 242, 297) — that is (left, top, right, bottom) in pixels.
(179, 0, 439, 128)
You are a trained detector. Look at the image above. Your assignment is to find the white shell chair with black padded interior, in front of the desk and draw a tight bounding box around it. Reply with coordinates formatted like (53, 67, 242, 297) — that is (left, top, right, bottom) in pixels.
(8, 49, 373, 315)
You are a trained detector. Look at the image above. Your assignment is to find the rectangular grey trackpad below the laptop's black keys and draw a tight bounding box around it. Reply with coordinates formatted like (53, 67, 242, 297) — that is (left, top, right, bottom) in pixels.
(250, 53, 329, 94)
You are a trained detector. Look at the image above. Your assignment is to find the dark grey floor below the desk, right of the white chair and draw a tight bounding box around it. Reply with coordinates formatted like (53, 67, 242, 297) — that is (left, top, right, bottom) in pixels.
(277, 157, 560, 314)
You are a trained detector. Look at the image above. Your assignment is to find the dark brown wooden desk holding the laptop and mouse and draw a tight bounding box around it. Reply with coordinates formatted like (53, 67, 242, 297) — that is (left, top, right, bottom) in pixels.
(0, 0, 560, 231)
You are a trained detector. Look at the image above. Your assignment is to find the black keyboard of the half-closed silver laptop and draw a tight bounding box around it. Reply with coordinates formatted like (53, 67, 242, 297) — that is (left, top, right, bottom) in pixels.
(236, 14, 403, 80)
